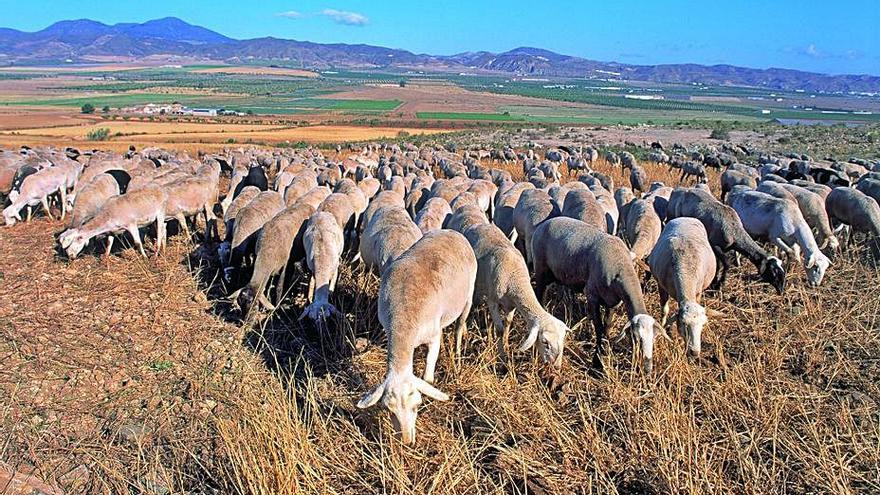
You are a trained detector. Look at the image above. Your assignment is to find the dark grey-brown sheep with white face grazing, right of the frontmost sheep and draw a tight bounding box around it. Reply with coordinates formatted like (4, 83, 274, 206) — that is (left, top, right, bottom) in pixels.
(532, 217, 668, 372)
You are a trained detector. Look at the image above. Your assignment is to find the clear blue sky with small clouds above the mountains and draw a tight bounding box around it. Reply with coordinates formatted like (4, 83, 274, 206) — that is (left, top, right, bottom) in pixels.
(0, 0, 880, 75)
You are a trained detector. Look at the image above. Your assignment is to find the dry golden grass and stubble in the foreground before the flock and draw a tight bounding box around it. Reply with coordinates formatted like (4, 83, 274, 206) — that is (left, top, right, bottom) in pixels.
(0, 157, 880, 494)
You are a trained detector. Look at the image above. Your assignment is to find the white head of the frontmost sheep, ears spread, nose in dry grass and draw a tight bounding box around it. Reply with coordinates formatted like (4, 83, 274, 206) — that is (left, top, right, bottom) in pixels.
(357, 372, 449, 444)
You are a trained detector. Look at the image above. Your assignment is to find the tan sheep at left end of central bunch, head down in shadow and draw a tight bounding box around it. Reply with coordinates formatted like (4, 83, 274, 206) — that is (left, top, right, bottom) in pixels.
(221, 191, 284, 284)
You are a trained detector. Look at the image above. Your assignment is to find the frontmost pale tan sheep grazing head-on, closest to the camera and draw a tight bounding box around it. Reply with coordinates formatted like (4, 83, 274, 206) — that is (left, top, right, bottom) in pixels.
(357, 230, 477, 444)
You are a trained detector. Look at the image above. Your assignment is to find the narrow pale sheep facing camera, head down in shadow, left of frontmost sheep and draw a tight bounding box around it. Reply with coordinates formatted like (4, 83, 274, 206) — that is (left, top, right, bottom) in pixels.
(299, 211, 344, 321)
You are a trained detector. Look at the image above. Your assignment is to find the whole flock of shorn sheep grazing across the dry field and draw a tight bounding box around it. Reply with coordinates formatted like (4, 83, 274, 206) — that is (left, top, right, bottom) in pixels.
(0, 143, 880, 443)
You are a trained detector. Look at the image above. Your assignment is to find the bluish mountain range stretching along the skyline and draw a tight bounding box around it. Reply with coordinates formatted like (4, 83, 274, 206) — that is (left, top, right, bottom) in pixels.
(0, 17, 880, 92)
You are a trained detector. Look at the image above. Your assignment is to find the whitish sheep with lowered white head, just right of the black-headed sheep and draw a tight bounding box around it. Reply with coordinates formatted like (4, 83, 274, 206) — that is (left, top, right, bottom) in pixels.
(728, 191, 831, 287)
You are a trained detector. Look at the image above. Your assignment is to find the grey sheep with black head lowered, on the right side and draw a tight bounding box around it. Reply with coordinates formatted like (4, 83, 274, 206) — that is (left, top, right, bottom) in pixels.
(666, 188, 785, 294)
